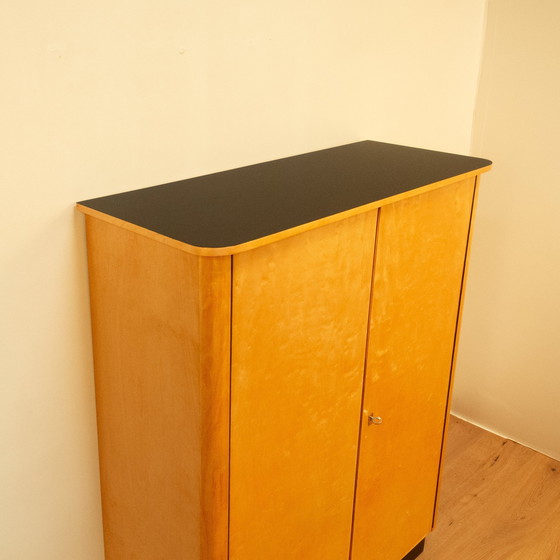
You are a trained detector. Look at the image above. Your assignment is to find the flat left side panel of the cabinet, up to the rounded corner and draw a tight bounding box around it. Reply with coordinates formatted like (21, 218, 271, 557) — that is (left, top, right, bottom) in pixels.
(87, 217, 229, 560)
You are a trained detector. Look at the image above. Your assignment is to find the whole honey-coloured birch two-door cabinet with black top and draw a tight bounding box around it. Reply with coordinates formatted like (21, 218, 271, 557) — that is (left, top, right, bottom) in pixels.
(78, 141, 491, 560)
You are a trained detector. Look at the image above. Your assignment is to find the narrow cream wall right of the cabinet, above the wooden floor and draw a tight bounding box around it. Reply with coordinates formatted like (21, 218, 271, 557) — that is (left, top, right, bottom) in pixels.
(454, 0, 560, 459)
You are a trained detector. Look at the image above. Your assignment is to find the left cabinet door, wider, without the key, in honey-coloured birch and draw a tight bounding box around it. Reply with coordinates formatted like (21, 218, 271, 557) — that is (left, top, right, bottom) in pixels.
(230, 211, 376, 560)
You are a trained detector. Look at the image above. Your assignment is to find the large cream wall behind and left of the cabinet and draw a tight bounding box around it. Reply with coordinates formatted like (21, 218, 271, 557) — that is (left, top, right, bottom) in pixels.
(0, 0, 484, 560)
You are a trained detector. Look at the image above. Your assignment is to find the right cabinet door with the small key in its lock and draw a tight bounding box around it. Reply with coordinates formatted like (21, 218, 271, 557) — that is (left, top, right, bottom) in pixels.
(352, 179, 475, 560)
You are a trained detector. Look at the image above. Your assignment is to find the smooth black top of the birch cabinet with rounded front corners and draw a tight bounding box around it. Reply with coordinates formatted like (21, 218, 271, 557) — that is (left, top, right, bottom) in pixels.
(79, 141, 491, 248)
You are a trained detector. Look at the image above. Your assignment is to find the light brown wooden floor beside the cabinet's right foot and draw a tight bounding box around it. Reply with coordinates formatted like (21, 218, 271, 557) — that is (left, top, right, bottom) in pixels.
(419, 417, 560, 560)
